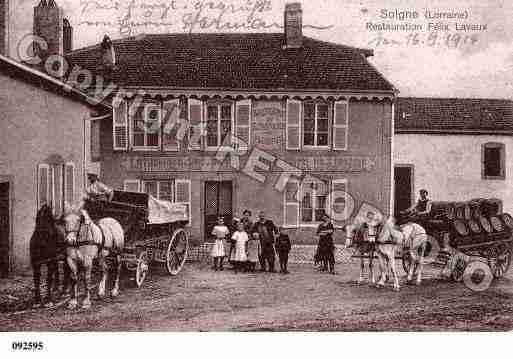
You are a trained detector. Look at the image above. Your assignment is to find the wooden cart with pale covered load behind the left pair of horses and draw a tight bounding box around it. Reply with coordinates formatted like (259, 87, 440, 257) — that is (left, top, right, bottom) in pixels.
(86, 191, 189, 287)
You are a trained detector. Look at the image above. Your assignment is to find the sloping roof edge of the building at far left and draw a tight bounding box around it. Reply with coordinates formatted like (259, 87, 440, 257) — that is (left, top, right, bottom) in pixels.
(0, 55, 110, 112)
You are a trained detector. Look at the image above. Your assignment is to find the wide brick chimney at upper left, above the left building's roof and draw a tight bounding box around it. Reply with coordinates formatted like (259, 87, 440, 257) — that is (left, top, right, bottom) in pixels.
(34, 0, 64, 59)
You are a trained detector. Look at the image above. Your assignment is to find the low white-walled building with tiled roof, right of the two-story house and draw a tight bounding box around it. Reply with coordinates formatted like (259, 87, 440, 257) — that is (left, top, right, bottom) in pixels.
(394, 97, 513, 213)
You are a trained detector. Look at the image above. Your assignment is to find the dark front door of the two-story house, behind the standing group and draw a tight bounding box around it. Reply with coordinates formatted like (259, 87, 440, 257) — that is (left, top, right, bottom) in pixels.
(204, 181, 233, 241)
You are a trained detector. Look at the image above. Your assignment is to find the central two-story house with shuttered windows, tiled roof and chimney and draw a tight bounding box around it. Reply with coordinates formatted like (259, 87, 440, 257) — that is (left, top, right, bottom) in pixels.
(67, 3, 396, 243)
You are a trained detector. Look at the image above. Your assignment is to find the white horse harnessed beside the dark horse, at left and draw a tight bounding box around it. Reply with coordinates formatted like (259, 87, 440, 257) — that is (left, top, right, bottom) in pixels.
(63, 209, 125, 309)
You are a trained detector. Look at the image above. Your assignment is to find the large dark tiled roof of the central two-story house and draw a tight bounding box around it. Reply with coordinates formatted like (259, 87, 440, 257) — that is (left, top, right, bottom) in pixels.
(67, 33, 395, 92)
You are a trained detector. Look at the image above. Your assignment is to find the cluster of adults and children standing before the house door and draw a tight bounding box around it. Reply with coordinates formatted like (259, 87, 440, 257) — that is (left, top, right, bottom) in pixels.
(211, 210, 291, 274)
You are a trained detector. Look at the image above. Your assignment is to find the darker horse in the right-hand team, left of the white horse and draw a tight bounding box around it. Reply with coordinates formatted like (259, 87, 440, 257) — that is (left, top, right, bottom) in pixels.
(344, 221, 376, 284)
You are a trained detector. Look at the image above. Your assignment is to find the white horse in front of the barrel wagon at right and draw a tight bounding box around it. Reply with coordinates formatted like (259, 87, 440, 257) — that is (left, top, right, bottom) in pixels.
(376, 217, 429, 291)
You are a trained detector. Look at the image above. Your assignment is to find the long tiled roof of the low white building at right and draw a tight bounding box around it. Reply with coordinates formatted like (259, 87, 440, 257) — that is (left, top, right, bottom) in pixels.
(395, 97, 513, 134)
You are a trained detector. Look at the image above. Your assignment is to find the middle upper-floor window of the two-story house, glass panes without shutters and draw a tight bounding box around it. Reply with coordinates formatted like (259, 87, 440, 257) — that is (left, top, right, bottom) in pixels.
(206, 102, 233, 149)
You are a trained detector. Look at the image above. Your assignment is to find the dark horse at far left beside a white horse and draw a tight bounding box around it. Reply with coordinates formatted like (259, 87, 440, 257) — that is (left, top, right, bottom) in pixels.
(30, 204, 70, 305)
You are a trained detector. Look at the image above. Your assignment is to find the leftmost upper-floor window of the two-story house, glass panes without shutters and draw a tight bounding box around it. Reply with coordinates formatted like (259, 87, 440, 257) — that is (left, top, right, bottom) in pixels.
(131, 103, 162, 150)
